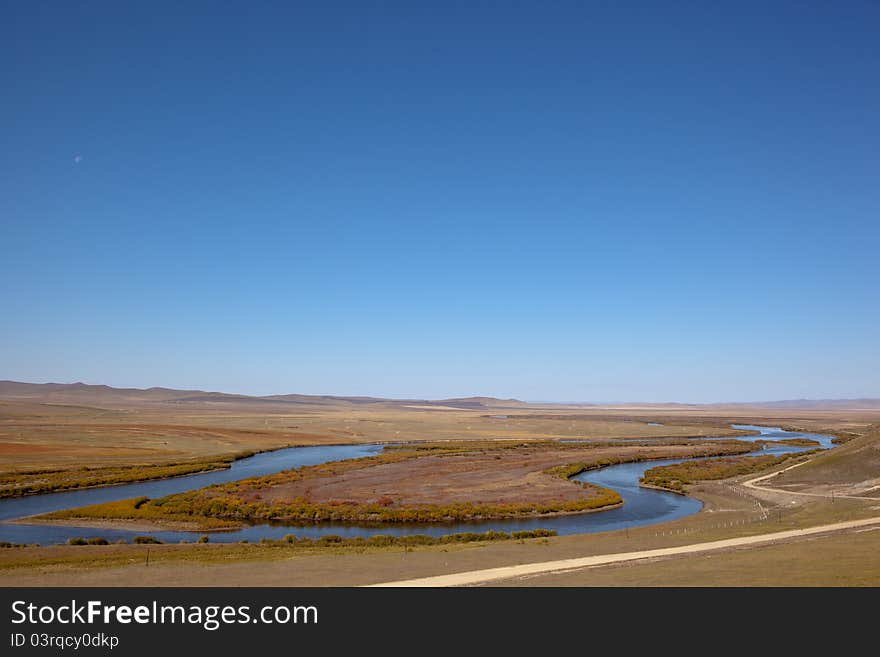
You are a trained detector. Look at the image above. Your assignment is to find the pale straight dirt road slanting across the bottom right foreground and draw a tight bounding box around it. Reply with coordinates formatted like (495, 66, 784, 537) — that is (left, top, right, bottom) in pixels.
(371, 516, 880, 587)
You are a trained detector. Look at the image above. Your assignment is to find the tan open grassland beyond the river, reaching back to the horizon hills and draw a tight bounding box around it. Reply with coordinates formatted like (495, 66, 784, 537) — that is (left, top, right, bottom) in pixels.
(0, 382, 880, 490)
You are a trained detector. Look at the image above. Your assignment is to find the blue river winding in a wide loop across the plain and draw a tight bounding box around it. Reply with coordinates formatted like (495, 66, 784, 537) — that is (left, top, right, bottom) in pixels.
(0, 424, 833, 545)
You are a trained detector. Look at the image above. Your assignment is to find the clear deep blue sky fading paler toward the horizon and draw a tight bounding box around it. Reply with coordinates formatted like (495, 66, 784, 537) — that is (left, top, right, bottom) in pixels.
(0, 1, 880, 402)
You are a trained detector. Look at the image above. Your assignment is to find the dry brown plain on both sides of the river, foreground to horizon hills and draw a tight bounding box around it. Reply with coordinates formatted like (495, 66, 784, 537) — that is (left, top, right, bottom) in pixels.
(0, 382, 880, 586)
